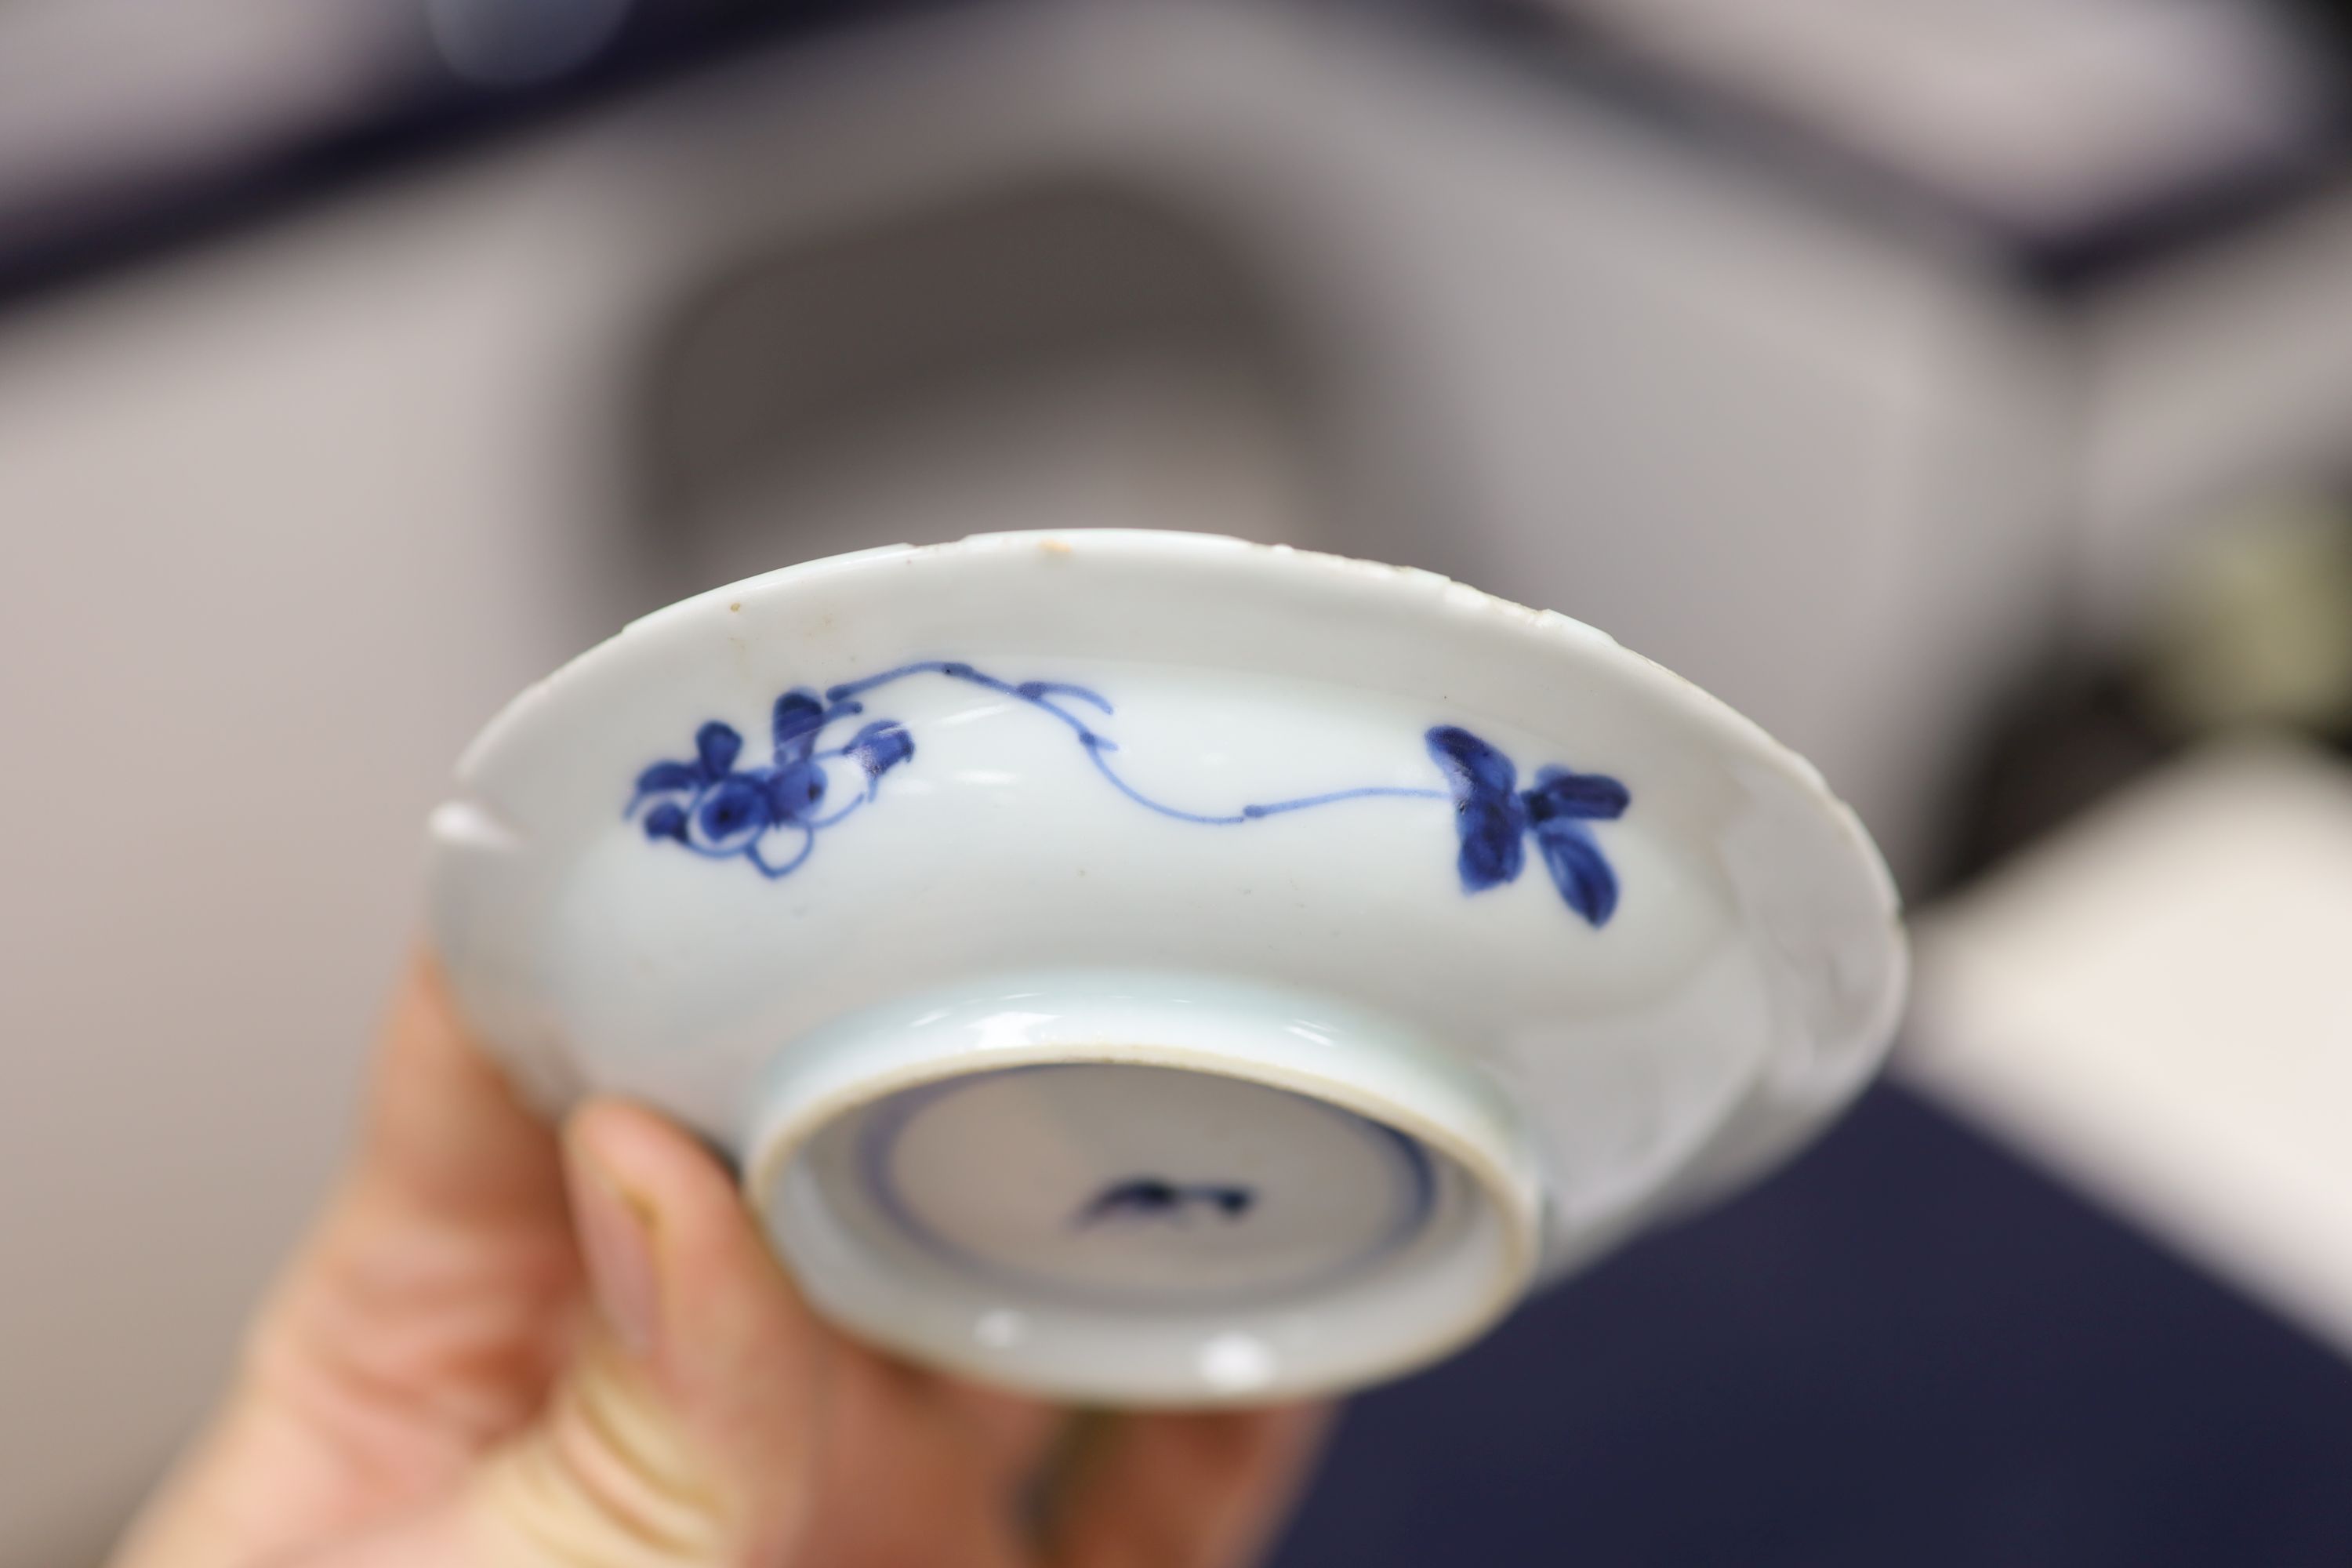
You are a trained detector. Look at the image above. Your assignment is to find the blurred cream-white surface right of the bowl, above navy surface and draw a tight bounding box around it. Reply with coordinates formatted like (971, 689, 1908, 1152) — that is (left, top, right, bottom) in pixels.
(1900, 741, 2352, 1354)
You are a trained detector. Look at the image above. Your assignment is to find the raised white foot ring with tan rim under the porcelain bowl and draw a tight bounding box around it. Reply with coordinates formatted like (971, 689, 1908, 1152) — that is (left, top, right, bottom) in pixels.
(739, 968, 1545, 1403)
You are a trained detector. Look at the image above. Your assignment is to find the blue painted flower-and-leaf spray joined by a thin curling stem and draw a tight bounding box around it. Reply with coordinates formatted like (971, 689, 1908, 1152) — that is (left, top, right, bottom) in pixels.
(623, 659, 1632, 926)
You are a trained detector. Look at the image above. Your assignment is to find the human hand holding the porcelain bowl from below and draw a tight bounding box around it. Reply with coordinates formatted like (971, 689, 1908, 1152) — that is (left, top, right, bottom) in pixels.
(113, 966, 1322, 1568)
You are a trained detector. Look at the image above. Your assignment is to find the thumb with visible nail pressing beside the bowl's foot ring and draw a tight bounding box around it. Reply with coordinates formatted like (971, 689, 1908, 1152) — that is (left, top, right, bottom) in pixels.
(459, 1100, 828, 1568)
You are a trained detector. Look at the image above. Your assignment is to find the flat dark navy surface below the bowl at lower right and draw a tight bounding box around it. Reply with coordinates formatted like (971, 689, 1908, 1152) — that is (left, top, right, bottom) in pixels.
(1275, 1086, 2352, 1568)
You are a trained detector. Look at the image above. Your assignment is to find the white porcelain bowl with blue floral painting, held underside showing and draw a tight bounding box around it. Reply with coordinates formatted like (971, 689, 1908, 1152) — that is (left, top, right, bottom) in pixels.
(433, 532, 1905, 1403)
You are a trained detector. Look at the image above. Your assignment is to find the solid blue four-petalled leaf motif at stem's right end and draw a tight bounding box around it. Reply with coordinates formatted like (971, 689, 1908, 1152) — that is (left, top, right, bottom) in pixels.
(1428, 724, 1632, 926)
